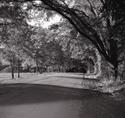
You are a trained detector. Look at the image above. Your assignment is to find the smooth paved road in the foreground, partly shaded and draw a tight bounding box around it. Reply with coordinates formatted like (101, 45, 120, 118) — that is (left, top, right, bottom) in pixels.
(0, 84, 125, 118)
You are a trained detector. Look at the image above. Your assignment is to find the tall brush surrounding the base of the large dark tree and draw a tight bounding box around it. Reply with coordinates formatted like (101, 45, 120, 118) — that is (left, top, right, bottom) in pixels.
(98, 54, 125, 82)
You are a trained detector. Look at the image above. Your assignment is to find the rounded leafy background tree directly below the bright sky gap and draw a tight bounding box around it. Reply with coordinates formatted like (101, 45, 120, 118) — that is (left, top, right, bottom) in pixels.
(31, 28, 67, 72)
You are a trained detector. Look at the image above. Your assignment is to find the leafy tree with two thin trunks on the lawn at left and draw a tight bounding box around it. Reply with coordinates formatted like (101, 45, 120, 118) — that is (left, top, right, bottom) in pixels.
(0, 14, 29, 78)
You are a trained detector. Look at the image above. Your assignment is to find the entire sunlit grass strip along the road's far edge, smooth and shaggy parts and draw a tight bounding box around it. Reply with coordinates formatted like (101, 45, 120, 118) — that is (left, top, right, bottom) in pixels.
(0, 72, 125, 94)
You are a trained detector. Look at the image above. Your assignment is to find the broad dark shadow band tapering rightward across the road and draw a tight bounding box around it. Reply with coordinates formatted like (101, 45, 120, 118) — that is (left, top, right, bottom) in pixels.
(0, 84, 102, 105)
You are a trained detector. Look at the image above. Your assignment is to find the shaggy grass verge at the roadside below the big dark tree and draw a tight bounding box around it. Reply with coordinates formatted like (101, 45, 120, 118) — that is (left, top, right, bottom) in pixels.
(82, 78, 125, 94)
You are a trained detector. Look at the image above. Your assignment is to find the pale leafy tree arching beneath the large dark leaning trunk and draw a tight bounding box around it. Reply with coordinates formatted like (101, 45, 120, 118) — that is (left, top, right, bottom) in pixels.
(47, 20, 101, 78)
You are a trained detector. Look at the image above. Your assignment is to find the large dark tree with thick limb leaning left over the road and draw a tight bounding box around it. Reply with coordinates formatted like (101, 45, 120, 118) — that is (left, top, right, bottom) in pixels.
(19, 0, 125, 79)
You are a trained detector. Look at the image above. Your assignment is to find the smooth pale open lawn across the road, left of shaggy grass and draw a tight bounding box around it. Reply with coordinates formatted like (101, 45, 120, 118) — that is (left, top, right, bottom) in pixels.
(0, 73, 83, 88)
